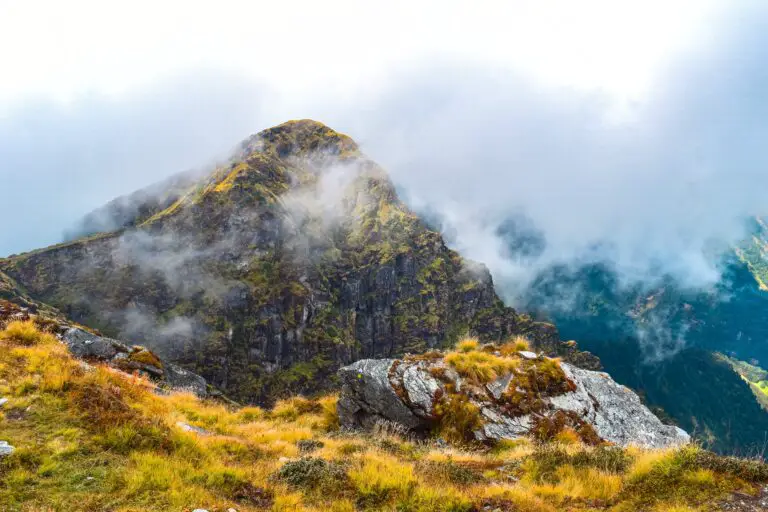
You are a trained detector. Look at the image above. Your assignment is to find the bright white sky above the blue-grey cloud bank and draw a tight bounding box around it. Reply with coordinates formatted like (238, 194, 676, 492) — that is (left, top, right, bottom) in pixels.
(0, 0, 725, 109)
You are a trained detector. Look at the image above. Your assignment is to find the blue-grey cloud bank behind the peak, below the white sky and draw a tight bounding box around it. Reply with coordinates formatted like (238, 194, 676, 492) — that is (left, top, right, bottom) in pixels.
(0, 4, 768, 314)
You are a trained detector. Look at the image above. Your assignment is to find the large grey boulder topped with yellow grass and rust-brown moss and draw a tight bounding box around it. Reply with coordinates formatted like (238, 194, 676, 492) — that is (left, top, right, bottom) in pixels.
(338, 346, 690, 448)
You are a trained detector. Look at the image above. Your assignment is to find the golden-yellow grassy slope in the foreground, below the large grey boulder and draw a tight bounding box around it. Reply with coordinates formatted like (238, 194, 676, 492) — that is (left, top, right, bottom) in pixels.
(0, 322, 768, 512)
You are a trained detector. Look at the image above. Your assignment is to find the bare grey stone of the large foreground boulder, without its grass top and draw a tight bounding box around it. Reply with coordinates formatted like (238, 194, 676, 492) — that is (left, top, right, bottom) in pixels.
(338, 358, 690, 448)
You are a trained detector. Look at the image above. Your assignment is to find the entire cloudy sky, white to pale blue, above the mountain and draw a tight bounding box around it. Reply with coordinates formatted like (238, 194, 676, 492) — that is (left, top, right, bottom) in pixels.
(0, 0, 768, 296)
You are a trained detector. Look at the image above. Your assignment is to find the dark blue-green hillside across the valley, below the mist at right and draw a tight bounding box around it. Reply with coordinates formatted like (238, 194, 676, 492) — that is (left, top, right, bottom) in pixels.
(526, 253, 768, 454)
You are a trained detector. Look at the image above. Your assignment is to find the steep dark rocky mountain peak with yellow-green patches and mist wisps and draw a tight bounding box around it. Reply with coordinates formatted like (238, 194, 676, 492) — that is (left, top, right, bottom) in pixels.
(0, 120, 599, 401)
